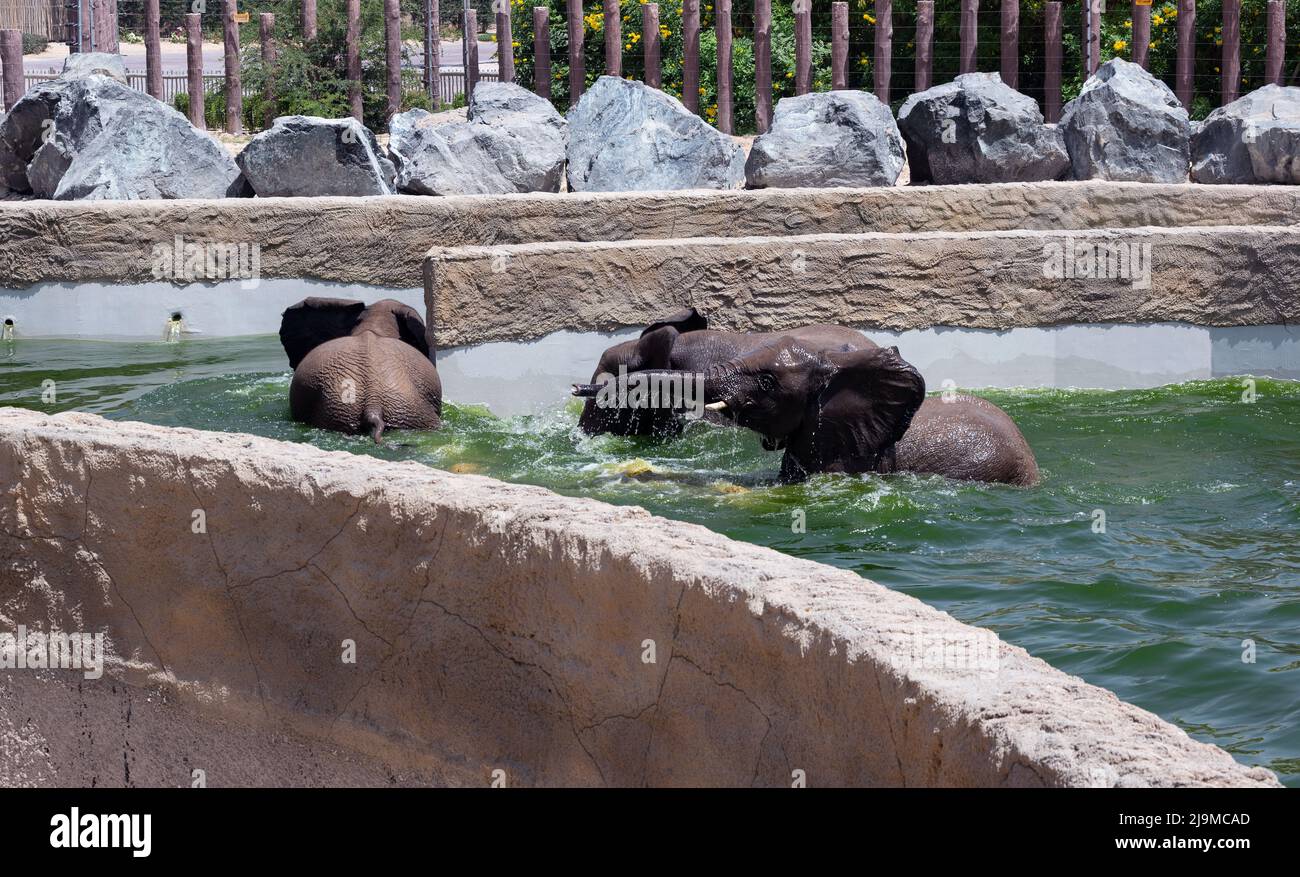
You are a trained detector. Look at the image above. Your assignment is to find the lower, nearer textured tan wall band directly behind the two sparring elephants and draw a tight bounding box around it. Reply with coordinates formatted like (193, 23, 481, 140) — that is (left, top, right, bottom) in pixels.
(425, 226, 1300, 346)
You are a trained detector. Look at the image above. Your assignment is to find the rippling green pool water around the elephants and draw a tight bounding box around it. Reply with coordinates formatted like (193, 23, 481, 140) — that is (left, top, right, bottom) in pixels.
(0, 337, 1300, 786)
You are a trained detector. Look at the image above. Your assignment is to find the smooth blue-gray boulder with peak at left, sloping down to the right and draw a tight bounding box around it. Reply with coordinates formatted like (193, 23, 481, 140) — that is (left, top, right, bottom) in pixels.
(568, 77, 745, 192)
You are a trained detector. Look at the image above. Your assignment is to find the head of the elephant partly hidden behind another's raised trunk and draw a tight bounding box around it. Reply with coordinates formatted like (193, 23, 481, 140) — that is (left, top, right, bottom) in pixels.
(573, 308, 709, 435)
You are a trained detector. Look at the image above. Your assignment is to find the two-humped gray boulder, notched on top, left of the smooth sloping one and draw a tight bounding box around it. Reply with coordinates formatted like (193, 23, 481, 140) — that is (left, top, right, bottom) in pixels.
(389, 82, 568, 195)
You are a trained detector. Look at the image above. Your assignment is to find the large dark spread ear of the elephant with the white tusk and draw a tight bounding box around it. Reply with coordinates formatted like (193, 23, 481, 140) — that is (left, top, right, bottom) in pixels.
(816, 347, 926, 465)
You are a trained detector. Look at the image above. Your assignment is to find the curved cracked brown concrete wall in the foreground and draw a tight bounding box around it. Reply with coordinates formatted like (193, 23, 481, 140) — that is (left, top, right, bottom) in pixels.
(0, 408, 1277, 786)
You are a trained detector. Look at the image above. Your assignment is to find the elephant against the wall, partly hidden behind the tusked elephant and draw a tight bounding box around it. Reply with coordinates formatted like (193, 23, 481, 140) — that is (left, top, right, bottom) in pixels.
(576, 308, 870, 435)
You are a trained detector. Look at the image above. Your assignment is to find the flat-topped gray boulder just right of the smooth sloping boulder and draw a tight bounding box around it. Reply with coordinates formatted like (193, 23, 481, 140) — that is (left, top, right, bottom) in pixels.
(745, 91, 907, 188)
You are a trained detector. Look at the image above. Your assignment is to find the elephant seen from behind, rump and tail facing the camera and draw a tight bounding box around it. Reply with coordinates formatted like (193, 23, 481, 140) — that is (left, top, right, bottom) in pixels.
(280, 298, 442, 444)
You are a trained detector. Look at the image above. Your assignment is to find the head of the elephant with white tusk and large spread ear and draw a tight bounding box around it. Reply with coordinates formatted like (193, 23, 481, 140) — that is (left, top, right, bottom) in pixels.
(703, 337, 926, 481)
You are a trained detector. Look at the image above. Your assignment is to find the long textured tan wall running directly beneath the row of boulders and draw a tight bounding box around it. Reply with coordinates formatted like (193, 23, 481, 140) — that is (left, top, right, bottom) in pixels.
(0, 182, 1300, 290)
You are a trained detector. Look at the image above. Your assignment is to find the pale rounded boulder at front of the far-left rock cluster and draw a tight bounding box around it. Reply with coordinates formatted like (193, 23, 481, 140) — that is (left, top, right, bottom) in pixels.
(55, 104, 239, 201)
